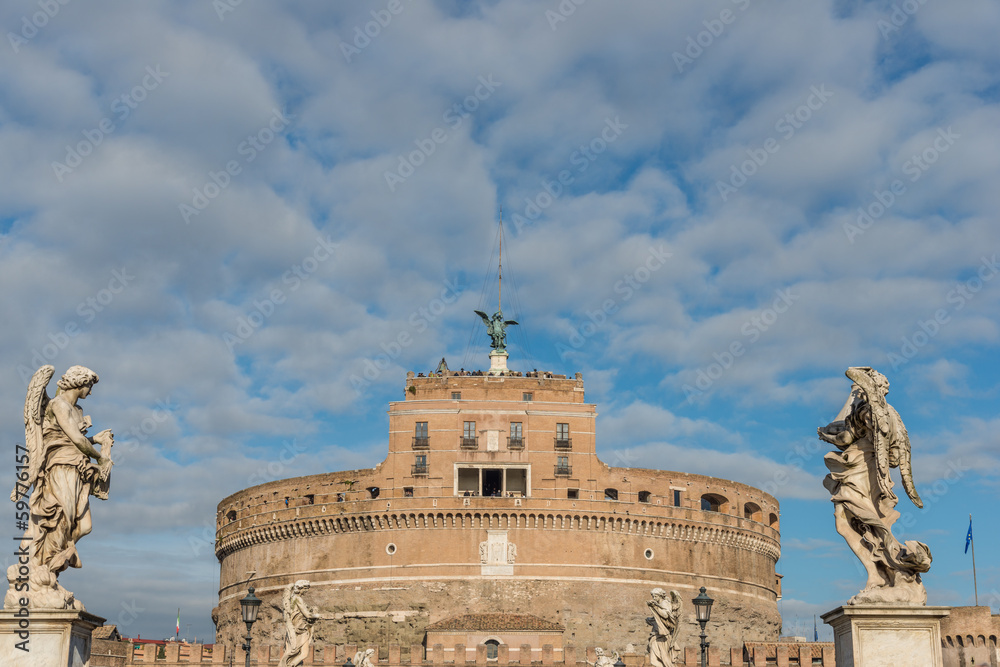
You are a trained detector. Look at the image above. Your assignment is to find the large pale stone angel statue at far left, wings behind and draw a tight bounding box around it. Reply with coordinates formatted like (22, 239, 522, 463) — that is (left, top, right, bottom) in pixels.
(4, 366, 114, 611)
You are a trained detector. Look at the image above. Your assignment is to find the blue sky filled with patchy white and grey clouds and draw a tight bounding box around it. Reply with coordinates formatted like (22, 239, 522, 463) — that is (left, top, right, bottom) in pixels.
(0, 0, 1000, 641)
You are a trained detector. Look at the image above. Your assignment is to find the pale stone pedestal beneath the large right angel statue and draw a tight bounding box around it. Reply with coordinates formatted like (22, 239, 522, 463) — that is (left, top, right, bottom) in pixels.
(822, 604, 950, 667)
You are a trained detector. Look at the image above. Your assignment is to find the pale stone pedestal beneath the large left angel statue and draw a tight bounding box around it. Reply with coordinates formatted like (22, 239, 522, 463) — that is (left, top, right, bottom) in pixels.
(0, 609, 104, 667)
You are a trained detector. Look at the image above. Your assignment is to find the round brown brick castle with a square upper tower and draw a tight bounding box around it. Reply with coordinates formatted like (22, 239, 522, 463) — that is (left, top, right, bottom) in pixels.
(215, 372, 781, 658)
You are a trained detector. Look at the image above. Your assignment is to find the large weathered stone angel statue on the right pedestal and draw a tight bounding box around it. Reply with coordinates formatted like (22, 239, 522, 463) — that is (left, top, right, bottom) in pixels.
(817, 366, 931, 605)
